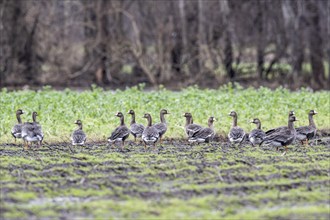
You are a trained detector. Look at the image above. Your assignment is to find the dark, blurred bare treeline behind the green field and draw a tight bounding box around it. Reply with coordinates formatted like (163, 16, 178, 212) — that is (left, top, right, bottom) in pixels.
(0, 0, 330, 89)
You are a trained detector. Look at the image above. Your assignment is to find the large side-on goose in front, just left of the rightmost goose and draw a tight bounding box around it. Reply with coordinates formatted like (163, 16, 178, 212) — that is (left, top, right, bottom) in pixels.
(260, 115, 298, 154)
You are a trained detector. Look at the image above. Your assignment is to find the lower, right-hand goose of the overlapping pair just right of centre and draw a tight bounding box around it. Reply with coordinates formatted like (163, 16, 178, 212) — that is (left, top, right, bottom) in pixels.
(188, 116, 216, 143)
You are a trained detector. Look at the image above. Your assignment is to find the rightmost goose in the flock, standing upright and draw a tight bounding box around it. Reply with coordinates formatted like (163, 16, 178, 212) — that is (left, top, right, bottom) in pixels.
(296, 110, 317, 145)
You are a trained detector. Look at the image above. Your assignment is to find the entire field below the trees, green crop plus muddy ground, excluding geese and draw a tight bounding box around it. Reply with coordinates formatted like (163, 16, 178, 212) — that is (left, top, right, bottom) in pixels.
(0, 86, 330, 219)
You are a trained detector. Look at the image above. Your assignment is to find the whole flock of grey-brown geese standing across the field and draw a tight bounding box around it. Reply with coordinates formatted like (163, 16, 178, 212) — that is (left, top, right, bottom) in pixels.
(11, 109, 317, 152)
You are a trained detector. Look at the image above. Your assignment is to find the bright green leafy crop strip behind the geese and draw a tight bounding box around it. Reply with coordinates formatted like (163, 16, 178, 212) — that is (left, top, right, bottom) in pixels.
(0, 85, 330, 143)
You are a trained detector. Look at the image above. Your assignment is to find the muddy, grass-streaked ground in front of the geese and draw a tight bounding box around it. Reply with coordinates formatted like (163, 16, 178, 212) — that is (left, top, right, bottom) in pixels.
(0, 135, 330, 219)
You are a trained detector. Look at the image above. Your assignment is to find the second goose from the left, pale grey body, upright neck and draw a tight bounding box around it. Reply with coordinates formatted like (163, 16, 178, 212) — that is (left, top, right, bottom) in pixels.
(22, 112, 44, 150)
